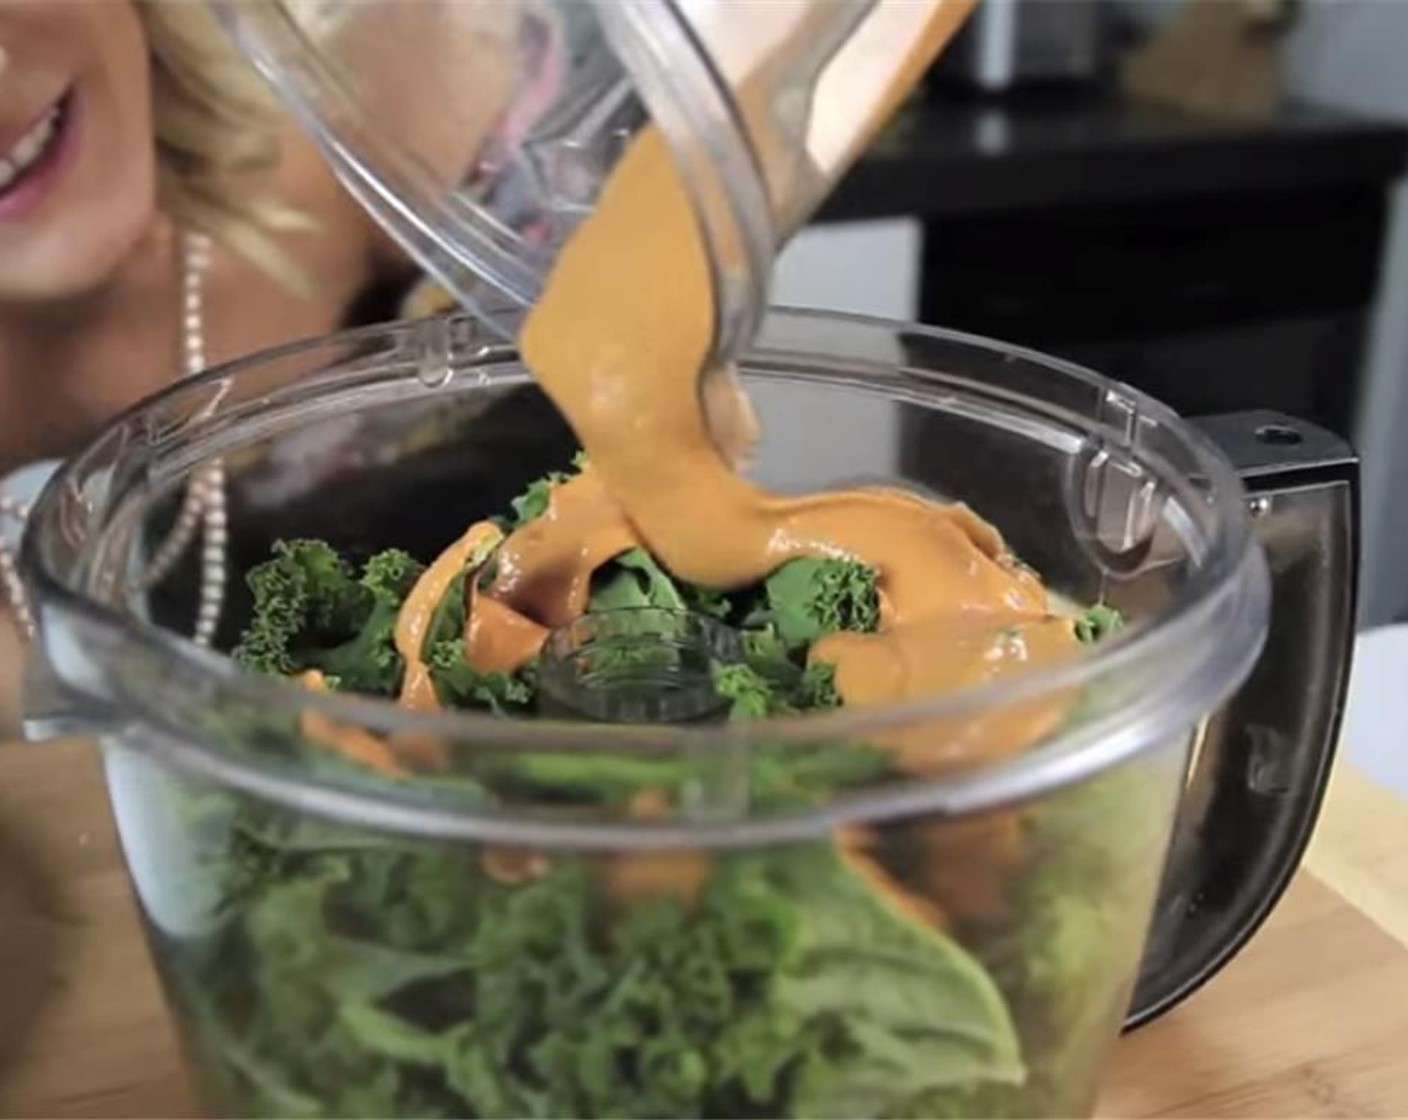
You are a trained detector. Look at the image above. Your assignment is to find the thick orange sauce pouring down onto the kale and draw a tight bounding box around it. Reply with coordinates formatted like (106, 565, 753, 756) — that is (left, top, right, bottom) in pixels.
(374, 7, 1077, 772)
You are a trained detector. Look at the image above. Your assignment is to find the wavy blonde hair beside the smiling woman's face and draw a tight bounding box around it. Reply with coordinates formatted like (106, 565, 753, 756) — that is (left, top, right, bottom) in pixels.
(137, 0, 313, 293)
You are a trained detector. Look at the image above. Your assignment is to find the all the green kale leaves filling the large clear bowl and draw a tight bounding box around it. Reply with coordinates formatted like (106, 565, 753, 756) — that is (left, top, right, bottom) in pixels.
(142, 456, 1160, 1117)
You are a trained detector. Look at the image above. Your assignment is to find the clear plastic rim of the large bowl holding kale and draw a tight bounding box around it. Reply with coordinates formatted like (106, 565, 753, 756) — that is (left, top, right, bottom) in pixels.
(21, 311, 1270, 847)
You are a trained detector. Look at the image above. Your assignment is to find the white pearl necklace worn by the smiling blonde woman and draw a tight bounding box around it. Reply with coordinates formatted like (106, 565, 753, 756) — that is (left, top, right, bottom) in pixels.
(0, 232, 230, 645)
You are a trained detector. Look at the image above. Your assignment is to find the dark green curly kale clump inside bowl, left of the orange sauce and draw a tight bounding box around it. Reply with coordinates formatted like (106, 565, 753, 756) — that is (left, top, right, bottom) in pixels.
(234, 541, 424, 696)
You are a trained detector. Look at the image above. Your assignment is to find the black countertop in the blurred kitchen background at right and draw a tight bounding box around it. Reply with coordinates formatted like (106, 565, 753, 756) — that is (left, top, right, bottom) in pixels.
(818, 89, 1408, 221)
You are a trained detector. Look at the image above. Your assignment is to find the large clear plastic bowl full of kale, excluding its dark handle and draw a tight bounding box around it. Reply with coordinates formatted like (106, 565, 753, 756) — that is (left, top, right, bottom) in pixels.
(23, 313, 1267, 1116)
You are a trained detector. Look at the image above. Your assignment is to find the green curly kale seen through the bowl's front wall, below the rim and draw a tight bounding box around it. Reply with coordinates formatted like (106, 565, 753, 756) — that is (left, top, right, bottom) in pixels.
(181, 828, 1021, 1117)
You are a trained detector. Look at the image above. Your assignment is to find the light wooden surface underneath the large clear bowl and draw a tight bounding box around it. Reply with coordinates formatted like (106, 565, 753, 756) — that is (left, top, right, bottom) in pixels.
(0, 742, 1408, 1117)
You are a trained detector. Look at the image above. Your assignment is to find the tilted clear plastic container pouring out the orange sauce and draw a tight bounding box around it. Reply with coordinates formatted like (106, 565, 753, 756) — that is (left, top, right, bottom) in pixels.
(213, 0, 974, 355)
